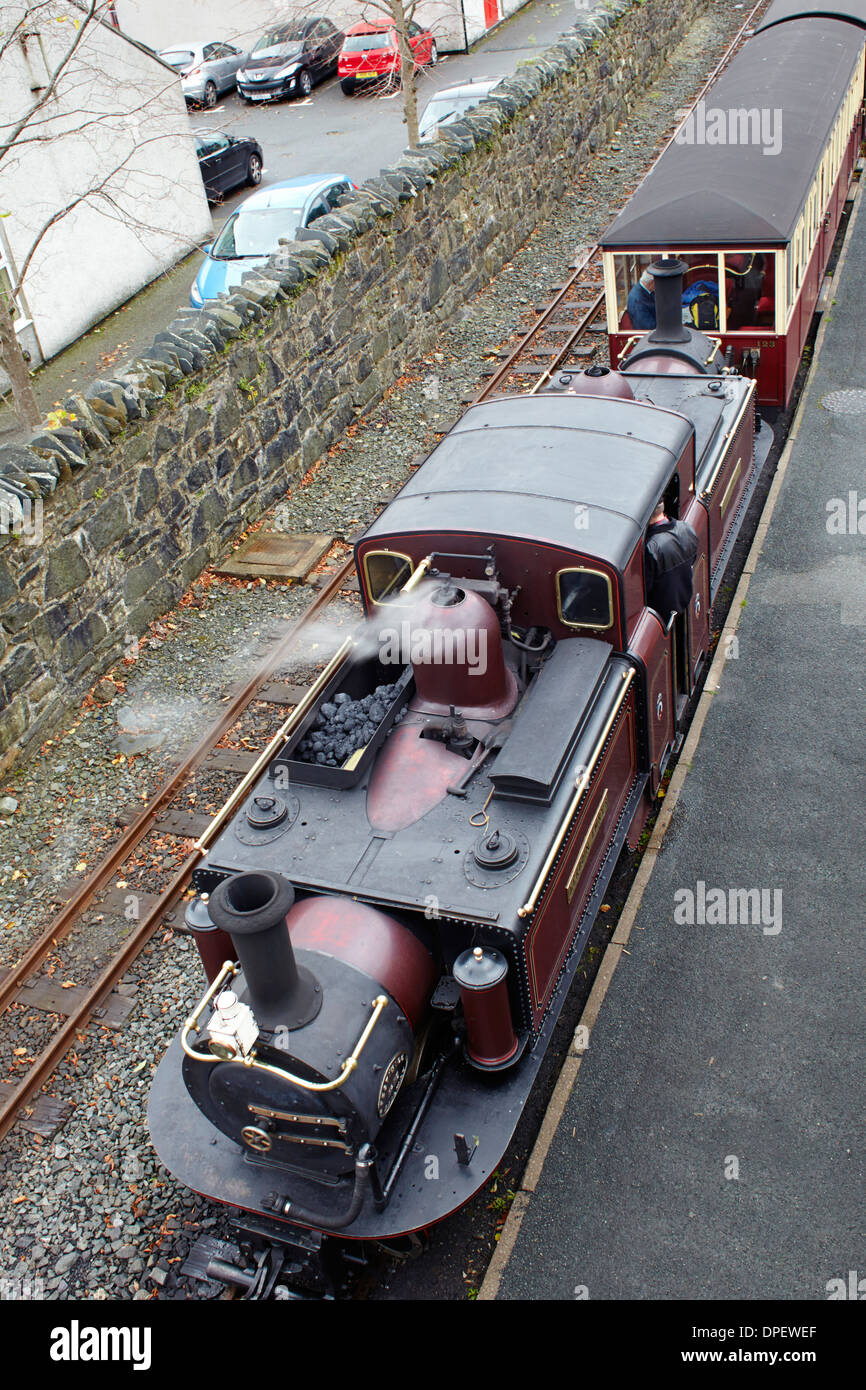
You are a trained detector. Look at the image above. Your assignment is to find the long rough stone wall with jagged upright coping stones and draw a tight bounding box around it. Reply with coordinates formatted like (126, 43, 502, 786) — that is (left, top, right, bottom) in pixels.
(0, 0, 702, 766)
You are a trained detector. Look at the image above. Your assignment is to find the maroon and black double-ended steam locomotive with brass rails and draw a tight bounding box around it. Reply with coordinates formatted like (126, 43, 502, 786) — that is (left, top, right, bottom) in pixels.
(150, 257, 770, 1295)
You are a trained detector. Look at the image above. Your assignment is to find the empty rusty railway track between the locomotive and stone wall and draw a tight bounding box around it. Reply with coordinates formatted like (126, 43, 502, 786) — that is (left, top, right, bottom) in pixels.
(0, 0, 769, 1141)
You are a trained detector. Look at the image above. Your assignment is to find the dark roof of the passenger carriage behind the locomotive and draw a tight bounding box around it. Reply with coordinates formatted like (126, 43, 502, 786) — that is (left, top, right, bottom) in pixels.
(601, 19, 863, 252)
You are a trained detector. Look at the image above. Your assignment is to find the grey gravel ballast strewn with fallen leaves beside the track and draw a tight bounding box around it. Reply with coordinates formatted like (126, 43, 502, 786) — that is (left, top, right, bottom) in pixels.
(0, 0, 744, 1300)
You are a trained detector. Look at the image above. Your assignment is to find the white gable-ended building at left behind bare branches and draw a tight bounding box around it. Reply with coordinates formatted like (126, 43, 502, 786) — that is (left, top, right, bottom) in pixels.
(0, 0, 211, 363)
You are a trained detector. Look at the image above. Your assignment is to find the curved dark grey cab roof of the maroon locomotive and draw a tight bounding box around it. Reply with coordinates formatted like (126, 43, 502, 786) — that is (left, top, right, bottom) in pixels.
(364, 395, 692, 570)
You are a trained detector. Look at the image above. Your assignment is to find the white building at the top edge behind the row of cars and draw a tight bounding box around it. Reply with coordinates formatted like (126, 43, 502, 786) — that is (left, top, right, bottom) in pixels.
(113, 0, 527, 53)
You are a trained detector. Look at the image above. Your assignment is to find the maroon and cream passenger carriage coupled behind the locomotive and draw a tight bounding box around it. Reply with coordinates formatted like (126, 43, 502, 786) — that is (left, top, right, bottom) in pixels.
(601, 0, 866, 406)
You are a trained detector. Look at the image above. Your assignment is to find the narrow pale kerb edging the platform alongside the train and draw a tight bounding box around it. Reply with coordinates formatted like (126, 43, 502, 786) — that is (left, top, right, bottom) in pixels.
(478, 189, 863, 1302)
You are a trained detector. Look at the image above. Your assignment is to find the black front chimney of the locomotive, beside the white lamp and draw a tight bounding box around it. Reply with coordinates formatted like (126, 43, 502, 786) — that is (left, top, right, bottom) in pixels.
(209, 872, 322, 1031)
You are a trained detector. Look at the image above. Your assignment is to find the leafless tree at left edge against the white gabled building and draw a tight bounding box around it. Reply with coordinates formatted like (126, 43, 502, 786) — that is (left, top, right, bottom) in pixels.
(0, 0, 203, 428)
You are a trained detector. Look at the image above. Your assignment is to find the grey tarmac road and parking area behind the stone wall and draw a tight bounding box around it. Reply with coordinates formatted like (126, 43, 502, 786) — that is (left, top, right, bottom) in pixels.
(0, 0, 595, 443)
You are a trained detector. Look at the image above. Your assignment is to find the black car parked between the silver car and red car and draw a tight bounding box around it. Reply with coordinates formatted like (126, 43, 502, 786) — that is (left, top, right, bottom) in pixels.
(238, 15, 343, 101)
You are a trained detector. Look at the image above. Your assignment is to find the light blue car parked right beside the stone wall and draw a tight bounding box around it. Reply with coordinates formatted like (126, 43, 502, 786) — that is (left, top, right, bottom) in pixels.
(189, 174, 356, 309)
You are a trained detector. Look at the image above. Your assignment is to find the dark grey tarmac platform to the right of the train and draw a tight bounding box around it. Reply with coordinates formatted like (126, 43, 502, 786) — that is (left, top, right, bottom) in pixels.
(498, 198, 866, 1300)
